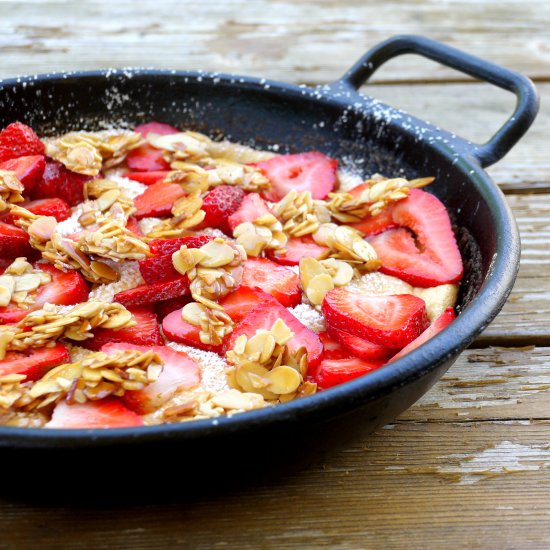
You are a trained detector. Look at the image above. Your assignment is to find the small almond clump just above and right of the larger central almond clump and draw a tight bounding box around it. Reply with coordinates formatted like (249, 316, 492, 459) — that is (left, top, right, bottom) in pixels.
(233, 214, 288, 256)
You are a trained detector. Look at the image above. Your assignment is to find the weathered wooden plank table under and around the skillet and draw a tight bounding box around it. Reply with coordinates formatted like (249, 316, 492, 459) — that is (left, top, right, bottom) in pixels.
(0, 0, 550, 549)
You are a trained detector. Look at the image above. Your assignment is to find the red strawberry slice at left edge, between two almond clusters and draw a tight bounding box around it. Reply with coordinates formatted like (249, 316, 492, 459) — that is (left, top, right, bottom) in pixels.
(0, 262, 89, 323)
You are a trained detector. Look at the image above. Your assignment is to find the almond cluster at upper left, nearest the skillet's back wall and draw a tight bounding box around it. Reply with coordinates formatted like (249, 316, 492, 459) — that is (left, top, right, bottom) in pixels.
(44, 130, 143, 176)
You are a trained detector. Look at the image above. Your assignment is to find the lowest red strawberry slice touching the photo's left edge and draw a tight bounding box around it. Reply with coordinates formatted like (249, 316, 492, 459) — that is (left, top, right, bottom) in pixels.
(0, 343, 71, 380)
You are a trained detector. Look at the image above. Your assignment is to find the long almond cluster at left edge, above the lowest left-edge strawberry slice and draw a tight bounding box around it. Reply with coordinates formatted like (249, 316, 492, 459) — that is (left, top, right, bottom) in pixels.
(0, 301, 136, 360)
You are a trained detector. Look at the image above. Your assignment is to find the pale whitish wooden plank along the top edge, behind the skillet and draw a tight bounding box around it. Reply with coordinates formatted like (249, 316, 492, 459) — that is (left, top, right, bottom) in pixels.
(0, 0, 550, 83)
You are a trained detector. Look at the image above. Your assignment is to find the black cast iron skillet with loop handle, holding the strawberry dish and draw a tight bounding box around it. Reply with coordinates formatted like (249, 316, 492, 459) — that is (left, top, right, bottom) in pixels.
(0, 36, 538, 494)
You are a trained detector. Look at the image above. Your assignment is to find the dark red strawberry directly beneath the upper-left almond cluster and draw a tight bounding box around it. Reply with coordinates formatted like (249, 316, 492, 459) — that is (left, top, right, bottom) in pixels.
(31, 161, 92, 206)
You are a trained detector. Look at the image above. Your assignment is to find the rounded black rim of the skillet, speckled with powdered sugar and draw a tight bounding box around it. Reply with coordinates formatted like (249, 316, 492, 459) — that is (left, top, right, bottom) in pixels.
(0, 68, 520, 450)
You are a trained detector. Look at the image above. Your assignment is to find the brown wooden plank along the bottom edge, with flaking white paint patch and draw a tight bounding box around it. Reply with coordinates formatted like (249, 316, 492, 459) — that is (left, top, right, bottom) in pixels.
(0, 421, 550, 550)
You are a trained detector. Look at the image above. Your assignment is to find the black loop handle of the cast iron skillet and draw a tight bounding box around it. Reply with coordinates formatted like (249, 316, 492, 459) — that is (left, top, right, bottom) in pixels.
(340, 35, 538, 168)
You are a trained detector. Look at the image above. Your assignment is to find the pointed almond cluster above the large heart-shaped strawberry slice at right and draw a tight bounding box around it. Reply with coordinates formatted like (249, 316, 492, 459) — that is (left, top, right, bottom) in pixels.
(326, 177, 435, 223)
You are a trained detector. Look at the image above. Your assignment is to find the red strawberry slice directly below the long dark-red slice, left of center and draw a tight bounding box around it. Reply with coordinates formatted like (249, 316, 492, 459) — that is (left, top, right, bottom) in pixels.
(81, 306, 164, 351)
